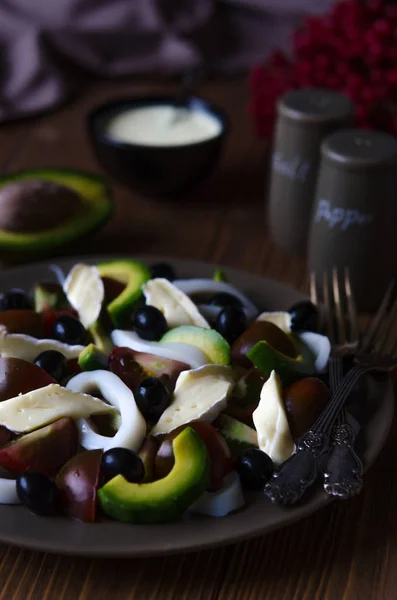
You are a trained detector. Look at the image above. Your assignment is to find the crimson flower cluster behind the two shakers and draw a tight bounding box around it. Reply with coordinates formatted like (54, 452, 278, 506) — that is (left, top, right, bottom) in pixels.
(250, 0, 397, 137)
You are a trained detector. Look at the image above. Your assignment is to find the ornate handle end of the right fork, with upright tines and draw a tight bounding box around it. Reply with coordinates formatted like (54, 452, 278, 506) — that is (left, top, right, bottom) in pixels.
(324, 423, 363, 499)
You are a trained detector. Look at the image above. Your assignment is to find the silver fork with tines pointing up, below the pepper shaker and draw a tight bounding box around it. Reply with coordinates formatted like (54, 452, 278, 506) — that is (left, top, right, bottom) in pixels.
(310, 268, 363, 499)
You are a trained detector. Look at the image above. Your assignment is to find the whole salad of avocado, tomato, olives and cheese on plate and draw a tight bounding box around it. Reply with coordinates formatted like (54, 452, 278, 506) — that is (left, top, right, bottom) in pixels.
(0, 259, 331, 524)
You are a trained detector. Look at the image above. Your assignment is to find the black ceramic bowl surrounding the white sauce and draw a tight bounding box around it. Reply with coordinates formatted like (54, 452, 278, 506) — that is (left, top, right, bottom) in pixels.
(87, 96, 229, 196)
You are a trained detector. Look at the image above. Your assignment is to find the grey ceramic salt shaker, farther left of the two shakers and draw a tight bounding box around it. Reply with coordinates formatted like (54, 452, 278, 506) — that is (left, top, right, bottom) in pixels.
(268, 88, 354, 256)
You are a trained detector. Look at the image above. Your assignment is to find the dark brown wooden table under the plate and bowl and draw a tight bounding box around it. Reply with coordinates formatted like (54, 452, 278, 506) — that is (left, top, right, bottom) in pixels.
(0, 79, 397, 600)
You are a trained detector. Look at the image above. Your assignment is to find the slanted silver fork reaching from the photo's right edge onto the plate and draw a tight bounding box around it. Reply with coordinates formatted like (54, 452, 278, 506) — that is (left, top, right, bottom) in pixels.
(264, 278, 397, 504)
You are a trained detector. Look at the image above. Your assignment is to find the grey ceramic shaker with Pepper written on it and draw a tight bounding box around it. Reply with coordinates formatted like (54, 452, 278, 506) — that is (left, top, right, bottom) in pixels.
(309, 129, 397, 311)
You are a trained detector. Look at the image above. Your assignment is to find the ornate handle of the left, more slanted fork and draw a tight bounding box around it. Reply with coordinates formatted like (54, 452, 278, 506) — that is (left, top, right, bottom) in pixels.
(264, 365, 366, 504)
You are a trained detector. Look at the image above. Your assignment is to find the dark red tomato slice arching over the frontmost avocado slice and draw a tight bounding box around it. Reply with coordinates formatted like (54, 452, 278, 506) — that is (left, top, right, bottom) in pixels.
(156, 421, 234, 492)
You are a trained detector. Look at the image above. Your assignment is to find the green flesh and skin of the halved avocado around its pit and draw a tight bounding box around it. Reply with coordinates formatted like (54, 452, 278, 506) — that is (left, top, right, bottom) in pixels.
(0, 169, 113, 251)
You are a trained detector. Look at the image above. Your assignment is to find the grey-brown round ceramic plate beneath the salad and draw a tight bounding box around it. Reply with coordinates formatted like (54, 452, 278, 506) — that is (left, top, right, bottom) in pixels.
(0, 257, 394, 557)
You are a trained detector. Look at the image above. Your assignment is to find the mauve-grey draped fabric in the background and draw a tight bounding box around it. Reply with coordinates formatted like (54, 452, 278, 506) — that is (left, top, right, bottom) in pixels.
(0, 0, 333, 122)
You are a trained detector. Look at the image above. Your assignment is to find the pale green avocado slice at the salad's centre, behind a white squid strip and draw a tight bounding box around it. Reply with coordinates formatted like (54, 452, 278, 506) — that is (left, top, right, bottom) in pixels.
(160, 325, 230, 365)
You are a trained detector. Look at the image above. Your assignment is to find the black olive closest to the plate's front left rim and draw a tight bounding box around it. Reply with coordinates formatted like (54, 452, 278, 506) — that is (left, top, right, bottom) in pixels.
(16, 473, 57, 515)
